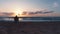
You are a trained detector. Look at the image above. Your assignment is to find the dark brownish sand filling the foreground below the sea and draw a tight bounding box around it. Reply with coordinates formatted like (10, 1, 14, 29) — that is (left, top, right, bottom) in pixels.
(0, 22, 60, 34)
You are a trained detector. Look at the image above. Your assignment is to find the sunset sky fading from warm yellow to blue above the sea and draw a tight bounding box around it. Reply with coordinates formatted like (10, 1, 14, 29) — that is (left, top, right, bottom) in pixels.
(0, 0, 60, 16)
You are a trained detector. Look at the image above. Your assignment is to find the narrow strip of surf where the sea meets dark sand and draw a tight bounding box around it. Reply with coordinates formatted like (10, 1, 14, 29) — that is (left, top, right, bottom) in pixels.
(0, 20, 60, 23)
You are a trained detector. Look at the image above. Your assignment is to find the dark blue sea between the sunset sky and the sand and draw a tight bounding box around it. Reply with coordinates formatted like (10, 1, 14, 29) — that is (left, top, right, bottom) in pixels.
(0, 17, 60, 22)
